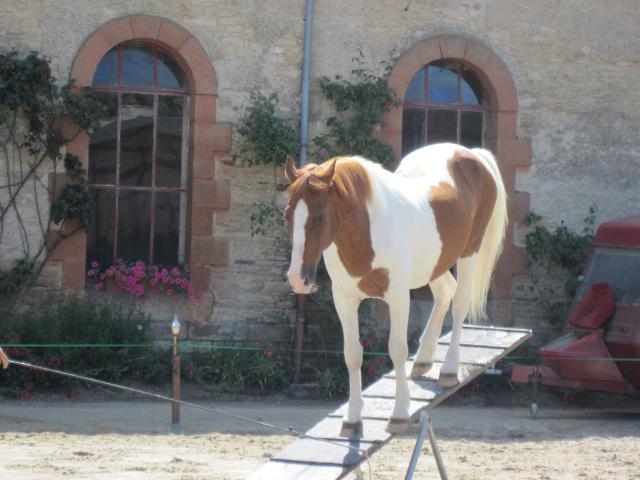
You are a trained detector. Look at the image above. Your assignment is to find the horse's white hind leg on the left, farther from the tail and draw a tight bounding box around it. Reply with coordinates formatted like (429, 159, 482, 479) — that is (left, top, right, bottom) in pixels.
(411, 272, 457, 378)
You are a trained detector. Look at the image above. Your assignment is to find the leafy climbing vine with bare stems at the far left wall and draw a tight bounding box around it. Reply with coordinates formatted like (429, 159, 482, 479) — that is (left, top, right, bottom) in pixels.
(0, 51, 101, 310)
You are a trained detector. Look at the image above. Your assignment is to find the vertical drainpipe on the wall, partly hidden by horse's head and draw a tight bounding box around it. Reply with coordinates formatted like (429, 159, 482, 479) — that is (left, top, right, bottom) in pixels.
(293, 0, 313, 383)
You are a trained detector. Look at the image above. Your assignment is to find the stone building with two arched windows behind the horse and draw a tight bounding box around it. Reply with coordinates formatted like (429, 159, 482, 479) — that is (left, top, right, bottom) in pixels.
(0, 0, 640, 341)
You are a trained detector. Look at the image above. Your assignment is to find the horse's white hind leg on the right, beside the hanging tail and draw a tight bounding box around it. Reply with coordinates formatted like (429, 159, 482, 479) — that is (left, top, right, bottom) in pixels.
(438, 254, 477, 387)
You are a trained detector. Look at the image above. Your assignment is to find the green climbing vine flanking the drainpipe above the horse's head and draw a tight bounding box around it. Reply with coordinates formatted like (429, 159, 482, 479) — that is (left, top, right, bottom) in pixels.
(234, 52, 399, 236)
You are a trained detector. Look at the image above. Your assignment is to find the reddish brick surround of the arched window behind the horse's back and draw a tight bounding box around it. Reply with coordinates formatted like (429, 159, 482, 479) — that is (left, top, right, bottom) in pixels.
(380, 35, 531, 324)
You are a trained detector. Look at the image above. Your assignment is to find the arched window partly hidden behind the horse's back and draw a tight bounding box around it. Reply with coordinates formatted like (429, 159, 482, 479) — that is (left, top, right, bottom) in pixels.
(402, 60, 489, 155)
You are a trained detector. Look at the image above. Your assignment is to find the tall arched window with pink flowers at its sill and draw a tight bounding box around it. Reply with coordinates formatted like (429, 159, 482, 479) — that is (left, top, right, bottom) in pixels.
(87, 42, 189, 266)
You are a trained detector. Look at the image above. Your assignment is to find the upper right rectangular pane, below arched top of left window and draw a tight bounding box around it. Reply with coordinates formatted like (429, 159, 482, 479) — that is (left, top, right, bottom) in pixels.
(156, 95, 185, 187)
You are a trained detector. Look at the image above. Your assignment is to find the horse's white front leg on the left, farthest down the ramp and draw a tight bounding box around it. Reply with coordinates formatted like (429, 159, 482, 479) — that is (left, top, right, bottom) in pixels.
(333, 288, 364, 437)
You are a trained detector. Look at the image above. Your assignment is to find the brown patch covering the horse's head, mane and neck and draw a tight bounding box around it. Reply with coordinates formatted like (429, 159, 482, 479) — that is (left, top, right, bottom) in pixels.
(285, 157, 374, 277)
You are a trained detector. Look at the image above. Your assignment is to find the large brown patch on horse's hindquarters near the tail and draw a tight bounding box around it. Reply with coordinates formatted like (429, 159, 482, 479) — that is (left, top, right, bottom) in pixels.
(429, 149, 497, 280)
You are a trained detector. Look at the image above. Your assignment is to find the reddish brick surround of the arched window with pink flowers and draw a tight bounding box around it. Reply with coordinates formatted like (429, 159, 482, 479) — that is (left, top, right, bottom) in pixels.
(51, 15, 231, 316)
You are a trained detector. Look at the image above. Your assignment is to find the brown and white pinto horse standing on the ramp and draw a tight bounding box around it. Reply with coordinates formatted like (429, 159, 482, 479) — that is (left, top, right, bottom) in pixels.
(284, 143, 508, 437)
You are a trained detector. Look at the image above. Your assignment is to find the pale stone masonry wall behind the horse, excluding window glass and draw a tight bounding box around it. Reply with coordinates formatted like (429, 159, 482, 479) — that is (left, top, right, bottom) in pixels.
(0, 0, 640, 343)
